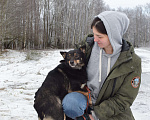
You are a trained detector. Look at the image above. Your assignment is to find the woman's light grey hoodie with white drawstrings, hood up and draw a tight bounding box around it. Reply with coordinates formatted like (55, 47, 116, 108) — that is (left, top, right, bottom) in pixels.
(87, 11, 129, 104)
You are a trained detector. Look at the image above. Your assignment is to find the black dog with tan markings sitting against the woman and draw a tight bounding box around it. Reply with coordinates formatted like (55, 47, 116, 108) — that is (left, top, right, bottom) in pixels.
(34, 47, 87, 120)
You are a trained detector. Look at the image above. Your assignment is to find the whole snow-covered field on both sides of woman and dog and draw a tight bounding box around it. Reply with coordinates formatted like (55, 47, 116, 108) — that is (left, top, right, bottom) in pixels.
(0, 48, 150, 120)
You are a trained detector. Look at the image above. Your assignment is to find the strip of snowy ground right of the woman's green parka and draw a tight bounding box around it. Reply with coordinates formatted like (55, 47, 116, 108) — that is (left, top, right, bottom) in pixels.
(131, 48, 150, 120)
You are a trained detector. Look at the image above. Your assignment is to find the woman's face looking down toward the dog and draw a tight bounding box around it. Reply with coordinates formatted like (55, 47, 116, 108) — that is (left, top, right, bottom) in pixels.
(93, 27, 112, 53)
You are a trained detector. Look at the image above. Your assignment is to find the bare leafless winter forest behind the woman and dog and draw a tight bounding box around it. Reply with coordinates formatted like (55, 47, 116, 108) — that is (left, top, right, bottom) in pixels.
(0, 0, 150, 53)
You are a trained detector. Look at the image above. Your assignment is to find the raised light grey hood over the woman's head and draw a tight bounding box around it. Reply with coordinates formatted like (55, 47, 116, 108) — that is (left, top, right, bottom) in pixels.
(96, 11, 129, 57)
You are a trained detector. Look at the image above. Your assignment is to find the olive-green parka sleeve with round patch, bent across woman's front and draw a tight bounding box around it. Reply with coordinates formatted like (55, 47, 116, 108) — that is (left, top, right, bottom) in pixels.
(94, 57, 141, 120)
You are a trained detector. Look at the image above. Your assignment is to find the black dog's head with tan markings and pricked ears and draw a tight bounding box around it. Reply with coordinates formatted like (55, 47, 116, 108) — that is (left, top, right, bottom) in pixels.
(60, 46, 85, 69)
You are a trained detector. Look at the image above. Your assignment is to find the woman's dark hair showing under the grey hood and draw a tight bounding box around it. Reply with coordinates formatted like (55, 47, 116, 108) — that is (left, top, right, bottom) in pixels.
(91, 17, 107, 35)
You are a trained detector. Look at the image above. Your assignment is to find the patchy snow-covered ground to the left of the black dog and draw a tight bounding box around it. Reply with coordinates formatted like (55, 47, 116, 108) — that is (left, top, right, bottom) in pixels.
(0, 50, 62, 120)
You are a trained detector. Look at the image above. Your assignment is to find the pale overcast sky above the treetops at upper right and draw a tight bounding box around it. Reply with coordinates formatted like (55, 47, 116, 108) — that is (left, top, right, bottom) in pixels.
(104, 0, 150, 9)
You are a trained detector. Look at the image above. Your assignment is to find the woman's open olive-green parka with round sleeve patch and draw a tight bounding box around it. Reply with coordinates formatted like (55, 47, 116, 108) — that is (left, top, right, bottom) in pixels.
(80, 35, 141, 120)
